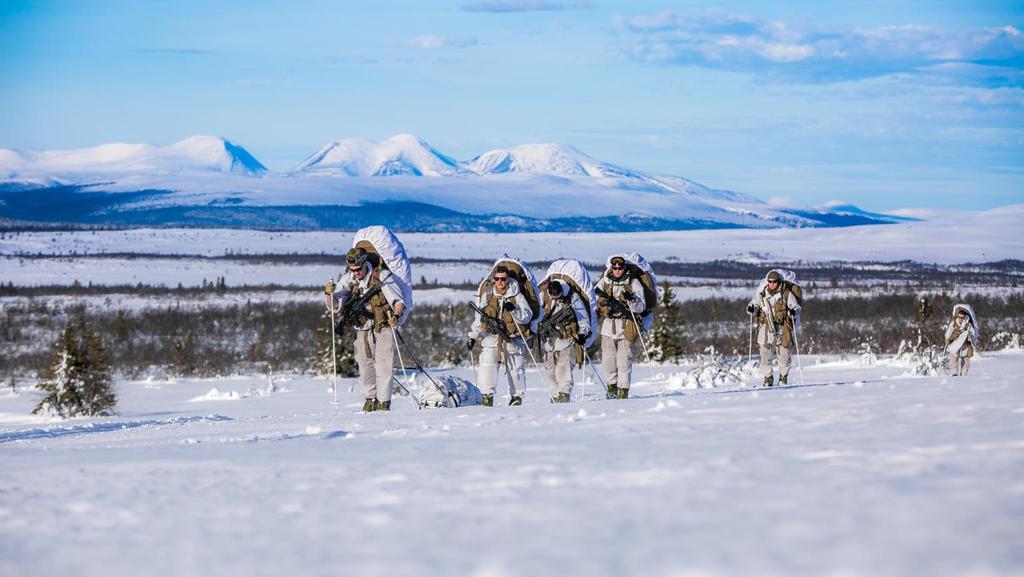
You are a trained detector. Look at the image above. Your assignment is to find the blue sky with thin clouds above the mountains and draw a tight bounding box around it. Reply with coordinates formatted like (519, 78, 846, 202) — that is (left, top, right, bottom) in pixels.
(0, 0, 1024, 210)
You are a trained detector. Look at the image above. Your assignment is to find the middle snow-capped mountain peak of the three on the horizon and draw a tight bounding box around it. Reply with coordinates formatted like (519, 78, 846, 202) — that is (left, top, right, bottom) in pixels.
(292, 134, 469, 176)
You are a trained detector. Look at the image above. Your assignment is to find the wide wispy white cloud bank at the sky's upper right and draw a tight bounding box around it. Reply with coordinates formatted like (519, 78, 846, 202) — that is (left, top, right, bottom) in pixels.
(614, 10, 1024, 81)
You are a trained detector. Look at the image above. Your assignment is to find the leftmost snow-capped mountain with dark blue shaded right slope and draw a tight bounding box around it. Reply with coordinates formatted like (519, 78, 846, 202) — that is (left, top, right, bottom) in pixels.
(0, 136, 266, 180)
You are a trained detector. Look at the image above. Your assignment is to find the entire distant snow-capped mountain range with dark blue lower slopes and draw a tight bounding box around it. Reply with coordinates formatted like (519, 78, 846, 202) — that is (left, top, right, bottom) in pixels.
(0, 134, 913, 232)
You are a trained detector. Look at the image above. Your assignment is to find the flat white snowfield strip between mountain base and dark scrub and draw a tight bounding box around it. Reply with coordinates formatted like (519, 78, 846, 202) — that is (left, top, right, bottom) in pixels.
(0, 205, 1024, 267)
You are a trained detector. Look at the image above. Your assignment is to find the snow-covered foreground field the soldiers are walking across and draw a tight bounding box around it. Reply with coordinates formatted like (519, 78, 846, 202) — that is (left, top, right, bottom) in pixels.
(0, 352, 1024, 577)
